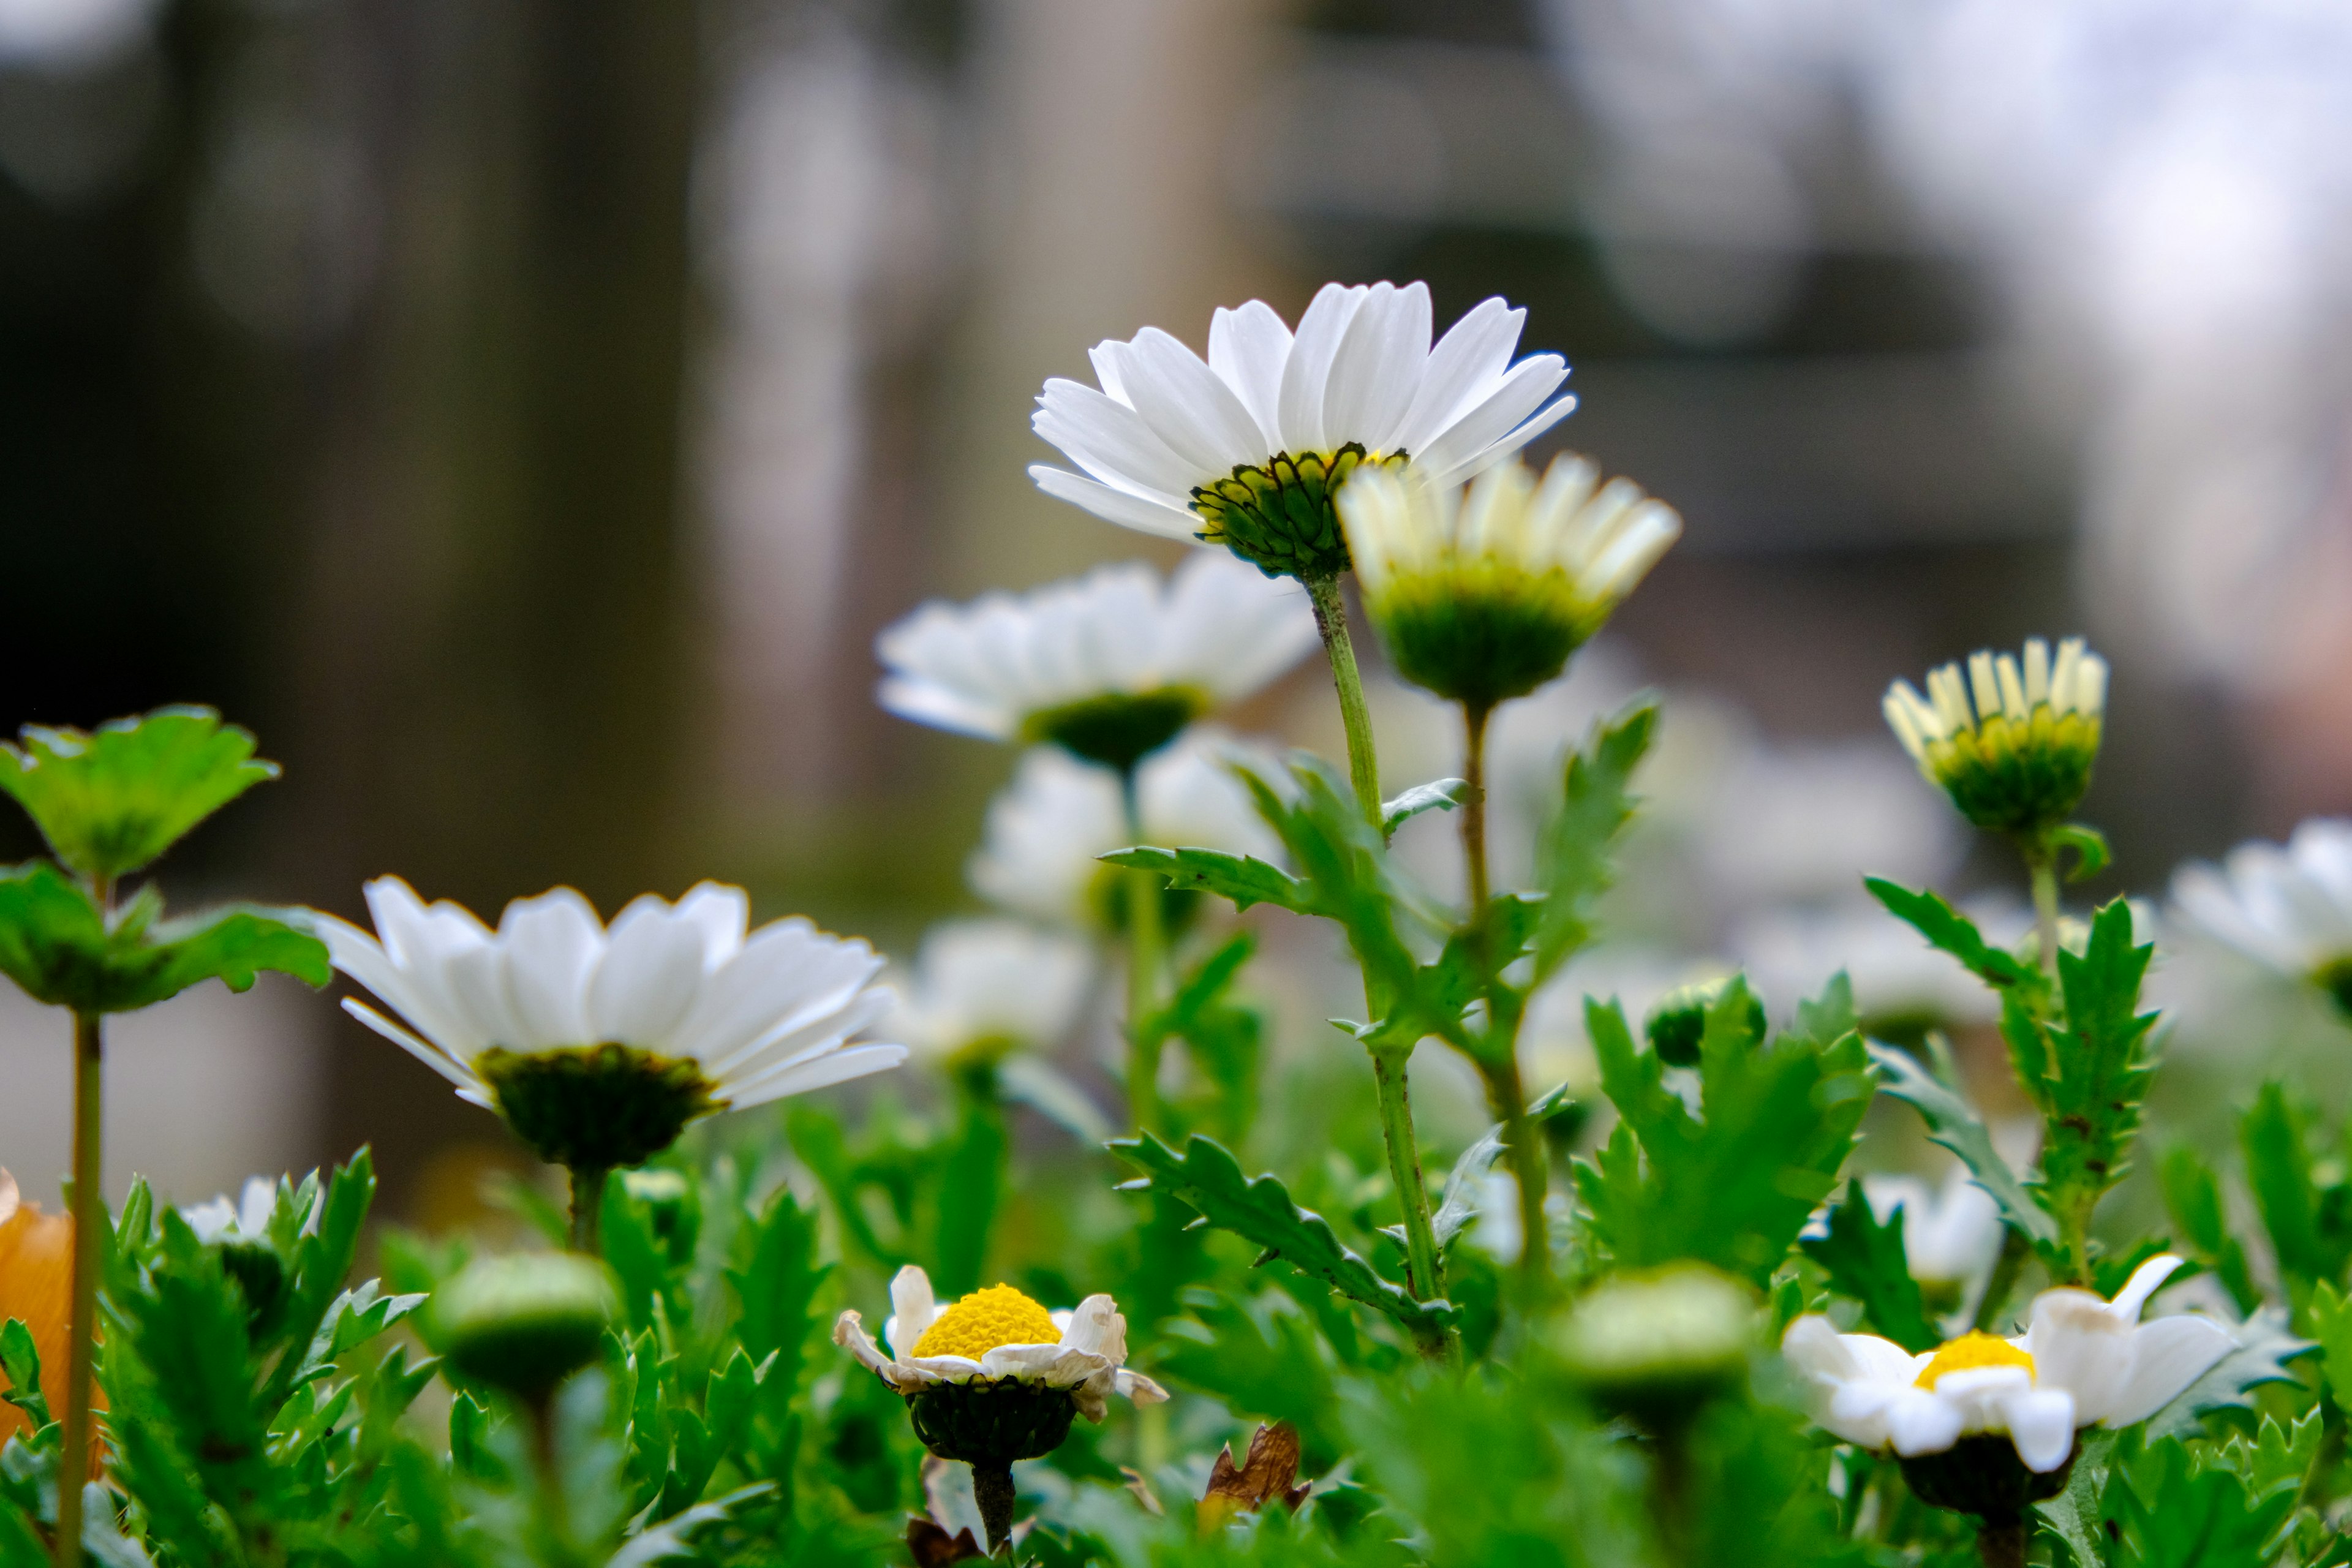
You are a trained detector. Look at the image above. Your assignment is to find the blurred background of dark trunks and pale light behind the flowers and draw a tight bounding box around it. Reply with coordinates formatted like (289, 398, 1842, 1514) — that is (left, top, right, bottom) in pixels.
(0, 0, 2352, 1213)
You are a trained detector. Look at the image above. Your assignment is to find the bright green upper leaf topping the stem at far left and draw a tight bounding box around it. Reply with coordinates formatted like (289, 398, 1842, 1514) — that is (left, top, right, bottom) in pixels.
(0, 707, 277, 877)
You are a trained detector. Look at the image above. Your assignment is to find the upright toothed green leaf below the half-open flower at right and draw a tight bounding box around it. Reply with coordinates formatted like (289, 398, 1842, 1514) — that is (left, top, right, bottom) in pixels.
(2037, 898, 2157, 1267)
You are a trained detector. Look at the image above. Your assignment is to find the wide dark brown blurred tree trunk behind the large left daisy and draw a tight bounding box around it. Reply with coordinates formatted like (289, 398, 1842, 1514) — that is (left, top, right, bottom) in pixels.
(301, 0, 698, 1213)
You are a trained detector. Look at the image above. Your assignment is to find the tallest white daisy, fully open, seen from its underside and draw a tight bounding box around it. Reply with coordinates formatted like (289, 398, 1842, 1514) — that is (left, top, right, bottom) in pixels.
(1030, 282, 1576, 578)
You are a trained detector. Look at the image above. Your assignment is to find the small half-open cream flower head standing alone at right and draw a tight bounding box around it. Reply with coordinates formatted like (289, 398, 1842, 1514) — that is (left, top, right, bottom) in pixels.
(1884, 637, 2108, 835)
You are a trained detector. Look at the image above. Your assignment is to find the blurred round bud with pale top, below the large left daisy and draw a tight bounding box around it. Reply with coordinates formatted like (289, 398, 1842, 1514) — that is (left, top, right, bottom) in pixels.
(431, 1253, 621, 1403)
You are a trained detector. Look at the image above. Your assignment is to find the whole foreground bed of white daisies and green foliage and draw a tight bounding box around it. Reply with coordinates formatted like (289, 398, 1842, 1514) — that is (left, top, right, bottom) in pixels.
(0, 282, 2352, 1568)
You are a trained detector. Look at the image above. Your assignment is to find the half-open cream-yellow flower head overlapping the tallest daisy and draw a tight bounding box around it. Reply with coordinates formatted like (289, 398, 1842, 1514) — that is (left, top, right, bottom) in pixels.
(1338, 456, 1682, 710)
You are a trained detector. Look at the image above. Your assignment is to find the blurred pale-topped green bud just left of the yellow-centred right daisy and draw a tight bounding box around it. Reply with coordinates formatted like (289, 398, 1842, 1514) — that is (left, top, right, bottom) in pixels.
(1559, 1262, 1755, 1427)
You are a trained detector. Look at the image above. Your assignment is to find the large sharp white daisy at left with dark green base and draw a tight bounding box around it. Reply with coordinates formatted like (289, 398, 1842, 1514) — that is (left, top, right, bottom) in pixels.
(320, 877, 905, 1166)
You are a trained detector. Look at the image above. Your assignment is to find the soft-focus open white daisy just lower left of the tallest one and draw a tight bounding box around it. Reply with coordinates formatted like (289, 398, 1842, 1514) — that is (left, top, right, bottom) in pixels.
(875, 552, 1315, 769)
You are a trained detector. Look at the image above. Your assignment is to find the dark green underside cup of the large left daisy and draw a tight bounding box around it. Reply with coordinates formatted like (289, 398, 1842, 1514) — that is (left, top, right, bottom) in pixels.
(473, 1041, 720, 1170)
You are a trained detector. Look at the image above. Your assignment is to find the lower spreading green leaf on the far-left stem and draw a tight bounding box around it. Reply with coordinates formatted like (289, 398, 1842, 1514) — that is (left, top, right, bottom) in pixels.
(0, 861, 334, 1013)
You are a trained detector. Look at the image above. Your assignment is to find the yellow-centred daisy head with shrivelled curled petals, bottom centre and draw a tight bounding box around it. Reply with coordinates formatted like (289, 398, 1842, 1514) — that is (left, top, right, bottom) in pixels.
(832, 1265, 1167, 1422)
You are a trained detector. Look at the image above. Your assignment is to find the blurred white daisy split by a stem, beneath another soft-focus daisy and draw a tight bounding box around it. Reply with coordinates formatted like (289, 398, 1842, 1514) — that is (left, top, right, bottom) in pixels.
(967, 729, 1282, 929)
